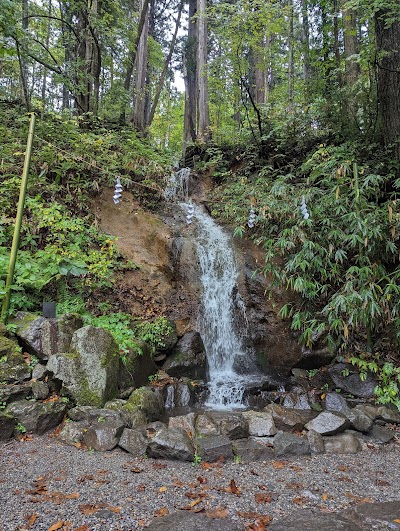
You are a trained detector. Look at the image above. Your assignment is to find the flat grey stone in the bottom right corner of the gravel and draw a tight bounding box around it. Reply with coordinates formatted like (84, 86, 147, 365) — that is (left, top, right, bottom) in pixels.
(342, 500, 400, 530)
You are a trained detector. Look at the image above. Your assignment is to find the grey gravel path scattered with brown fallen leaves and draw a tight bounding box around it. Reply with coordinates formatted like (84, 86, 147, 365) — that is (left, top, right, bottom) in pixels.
(0, 436, 400, 531)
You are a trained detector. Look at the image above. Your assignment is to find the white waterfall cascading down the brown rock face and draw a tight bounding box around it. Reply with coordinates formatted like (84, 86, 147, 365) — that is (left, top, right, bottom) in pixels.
(182, 204, 251, 409)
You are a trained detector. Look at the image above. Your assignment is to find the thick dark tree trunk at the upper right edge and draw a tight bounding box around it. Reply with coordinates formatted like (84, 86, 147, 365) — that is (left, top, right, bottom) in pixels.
(375, 9, 400, 161)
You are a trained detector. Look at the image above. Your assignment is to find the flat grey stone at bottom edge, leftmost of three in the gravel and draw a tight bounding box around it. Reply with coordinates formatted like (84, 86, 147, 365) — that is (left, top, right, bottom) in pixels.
(146, 511, 244, 531)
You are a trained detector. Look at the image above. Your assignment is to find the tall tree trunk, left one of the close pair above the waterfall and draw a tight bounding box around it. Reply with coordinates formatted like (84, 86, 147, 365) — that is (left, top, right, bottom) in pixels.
(183, 0, 197, 151)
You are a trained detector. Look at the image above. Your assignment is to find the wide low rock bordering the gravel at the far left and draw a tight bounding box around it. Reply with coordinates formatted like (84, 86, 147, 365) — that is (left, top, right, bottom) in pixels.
(5, 400, 67, 435)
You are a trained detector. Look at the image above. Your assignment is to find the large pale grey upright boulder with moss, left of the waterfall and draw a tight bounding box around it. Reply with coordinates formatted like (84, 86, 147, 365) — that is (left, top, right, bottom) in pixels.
(47, 326, 119, 407)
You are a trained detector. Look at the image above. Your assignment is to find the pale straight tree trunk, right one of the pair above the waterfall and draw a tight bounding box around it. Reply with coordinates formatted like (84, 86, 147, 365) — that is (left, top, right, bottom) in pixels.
(197, 0, 210, 142)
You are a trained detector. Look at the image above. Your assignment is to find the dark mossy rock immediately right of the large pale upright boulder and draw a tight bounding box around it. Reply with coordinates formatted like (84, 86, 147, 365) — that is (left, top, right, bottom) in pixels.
(118, 341, 158, 389)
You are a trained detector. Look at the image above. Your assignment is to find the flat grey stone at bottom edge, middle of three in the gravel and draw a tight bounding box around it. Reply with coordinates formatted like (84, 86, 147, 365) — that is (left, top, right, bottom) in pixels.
(268, 509, 365, 531)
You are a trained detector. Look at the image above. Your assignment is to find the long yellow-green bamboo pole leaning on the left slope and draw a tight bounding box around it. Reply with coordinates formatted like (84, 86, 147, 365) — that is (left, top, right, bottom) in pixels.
(1, 112, 35, 324)
